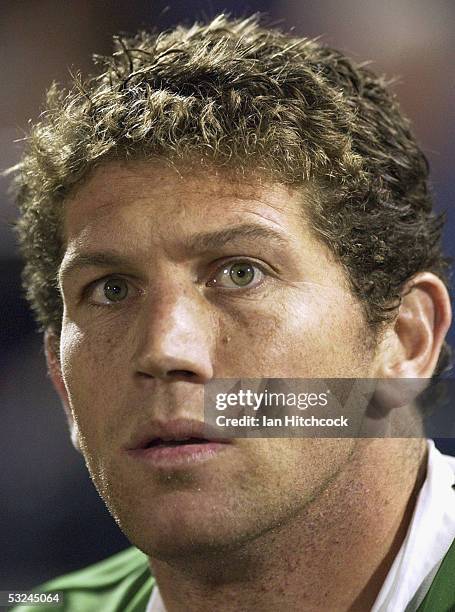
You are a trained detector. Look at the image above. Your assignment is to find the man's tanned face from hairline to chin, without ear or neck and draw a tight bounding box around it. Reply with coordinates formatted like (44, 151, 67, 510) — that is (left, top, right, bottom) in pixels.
(56, 162, 373, 558)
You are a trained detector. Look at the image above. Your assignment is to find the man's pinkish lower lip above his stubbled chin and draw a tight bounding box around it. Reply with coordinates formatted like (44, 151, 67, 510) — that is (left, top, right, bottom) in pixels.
(128, 442, 230, 468)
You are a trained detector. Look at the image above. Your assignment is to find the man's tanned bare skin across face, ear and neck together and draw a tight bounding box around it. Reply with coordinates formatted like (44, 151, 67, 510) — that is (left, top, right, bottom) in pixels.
(46, 161, 450, 612)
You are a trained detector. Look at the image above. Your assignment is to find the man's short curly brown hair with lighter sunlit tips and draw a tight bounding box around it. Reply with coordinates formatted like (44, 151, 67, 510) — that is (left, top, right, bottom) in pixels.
(10, 15, 450, 374)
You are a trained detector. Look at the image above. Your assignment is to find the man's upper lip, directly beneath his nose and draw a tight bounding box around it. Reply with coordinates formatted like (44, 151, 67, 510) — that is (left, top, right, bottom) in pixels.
(128, 419, 231, 450)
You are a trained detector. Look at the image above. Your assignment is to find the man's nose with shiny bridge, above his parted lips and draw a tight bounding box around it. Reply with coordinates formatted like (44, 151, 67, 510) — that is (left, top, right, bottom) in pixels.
(134, 288, 213, 383)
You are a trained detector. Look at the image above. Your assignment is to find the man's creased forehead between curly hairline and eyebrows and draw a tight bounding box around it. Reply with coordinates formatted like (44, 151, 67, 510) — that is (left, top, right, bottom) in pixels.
(64, 161, 314, 245)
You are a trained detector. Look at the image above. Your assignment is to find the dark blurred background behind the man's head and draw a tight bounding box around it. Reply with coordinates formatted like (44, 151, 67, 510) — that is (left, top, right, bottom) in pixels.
(0, 0, 455, 590)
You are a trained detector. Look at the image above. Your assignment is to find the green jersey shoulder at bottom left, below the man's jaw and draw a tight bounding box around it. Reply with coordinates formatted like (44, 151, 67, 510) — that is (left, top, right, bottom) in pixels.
(12, 547, 155, 612)
